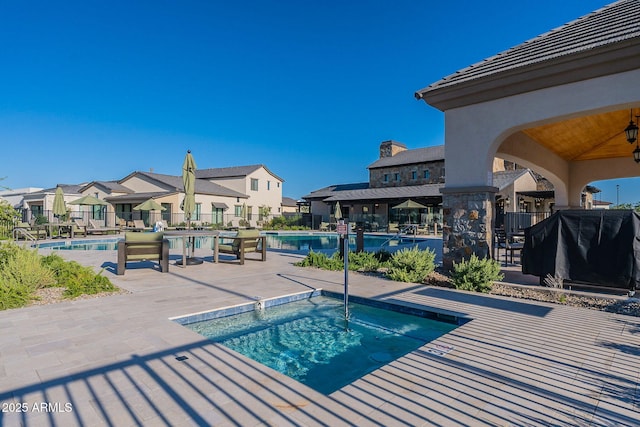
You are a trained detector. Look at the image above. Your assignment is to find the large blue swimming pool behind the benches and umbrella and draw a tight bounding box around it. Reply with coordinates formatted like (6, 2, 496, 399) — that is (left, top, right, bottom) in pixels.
(33, 232, 442, 253)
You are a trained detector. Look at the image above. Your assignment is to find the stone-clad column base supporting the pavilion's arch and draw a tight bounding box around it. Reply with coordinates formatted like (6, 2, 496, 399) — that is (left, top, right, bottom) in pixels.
(440, 186, 498, 270)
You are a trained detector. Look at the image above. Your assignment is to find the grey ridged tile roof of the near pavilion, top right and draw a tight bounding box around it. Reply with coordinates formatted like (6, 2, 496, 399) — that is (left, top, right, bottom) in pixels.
(416, 0, 640, 97)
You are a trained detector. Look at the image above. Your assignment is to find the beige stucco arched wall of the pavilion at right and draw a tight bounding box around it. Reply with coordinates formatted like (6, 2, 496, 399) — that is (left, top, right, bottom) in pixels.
(445, 69, 640, 208)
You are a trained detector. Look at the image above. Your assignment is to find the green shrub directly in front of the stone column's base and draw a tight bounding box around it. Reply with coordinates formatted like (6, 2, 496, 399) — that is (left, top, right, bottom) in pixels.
(451, 254, 504, 292)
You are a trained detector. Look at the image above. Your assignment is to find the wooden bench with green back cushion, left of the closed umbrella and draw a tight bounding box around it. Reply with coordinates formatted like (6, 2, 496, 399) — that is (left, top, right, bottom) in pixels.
(117, 232, 169, 275)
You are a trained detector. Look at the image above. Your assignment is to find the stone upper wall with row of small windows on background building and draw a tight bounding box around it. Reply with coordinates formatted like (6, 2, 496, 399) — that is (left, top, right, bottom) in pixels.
(369, 160, 444, 188)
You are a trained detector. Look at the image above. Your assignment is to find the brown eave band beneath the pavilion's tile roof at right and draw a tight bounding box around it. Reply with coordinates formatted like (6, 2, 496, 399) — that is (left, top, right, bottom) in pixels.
(415, 38, 640, 111)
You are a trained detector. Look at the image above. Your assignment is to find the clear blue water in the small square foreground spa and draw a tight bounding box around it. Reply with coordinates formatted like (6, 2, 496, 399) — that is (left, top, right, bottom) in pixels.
(184, 296, 457, 394)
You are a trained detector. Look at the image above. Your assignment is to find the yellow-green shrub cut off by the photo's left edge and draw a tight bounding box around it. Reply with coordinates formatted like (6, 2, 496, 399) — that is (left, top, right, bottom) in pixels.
(0, 244, 55, 310)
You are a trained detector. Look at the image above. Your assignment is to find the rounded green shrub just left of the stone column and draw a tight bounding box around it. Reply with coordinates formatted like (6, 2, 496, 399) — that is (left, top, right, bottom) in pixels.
(387, 247, 436, 283)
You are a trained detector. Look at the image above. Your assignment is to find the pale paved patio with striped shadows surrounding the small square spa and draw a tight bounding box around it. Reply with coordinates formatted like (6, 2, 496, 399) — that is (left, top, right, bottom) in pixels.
(0, 242, 640, 426)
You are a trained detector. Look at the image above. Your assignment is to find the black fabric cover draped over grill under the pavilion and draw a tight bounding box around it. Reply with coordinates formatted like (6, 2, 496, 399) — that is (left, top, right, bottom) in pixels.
(522, 210, 640, 289)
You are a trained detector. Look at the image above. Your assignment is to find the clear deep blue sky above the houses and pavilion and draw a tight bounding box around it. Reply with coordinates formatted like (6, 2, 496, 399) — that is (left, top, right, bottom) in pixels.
(0, 0, 640, 203)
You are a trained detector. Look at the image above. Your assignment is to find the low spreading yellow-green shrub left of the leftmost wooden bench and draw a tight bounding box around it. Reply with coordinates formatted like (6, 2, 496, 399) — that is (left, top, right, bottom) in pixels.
(42, 254, 117, 298)
